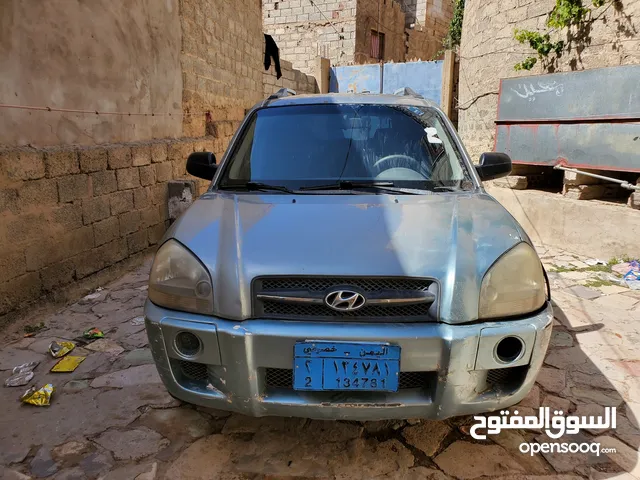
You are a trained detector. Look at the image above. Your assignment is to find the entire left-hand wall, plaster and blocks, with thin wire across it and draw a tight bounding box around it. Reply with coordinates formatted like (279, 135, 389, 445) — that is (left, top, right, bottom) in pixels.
(0, 0, 264, 321)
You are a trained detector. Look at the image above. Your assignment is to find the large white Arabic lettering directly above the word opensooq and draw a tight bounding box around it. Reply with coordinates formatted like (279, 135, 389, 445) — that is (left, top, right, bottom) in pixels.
(470, 407, 616, 440)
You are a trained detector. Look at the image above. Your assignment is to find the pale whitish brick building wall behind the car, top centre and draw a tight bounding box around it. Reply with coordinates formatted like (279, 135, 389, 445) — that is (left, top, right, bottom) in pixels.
(262, 0, 358, 74)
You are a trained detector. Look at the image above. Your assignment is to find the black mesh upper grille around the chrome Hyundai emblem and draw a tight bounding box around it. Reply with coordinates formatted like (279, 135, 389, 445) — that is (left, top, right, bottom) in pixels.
(253, 277, 437, 322)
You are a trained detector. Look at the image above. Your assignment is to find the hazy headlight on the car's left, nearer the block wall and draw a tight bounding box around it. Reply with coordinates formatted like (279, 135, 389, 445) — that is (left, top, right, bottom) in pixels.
(149, 240, 213, 314)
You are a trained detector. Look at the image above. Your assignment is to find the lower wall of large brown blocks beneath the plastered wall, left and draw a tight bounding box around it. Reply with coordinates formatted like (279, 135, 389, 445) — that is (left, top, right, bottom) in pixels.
(0, 137, 214, 317)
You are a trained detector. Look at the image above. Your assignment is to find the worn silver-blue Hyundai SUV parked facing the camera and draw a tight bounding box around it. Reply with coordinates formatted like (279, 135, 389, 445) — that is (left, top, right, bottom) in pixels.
(145, 89, 553, 420)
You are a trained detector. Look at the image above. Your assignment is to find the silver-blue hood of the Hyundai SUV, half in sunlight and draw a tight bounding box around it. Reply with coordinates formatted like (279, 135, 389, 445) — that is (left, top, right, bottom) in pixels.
(165, 192, 528, 323)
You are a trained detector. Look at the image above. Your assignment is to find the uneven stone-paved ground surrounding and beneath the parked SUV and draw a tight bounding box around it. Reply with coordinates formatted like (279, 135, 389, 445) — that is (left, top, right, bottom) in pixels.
(0, 248, 640, 480)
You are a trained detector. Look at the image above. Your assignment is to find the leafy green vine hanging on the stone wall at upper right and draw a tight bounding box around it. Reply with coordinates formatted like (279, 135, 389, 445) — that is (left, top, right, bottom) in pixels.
(513, 0, 614, 70)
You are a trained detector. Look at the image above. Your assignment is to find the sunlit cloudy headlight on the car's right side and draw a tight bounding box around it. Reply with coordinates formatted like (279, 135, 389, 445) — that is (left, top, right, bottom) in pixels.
(478, 243, 546, 318)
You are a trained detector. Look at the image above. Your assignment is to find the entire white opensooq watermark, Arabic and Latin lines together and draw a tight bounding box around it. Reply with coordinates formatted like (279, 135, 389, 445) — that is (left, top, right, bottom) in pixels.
(470, 407, 616, 456)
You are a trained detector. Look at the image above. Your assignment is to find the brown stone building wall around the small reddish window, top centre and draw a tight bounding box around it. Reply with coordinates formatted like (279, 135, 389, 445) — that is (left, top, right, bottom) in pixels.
(355, 0, 406, 64)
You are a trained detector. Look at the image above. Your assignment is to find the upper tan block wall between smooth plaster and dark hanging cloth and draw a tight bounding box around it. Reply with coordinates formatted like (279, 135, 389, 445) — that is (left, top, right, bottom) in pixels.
(180, 0, 264, 138)
